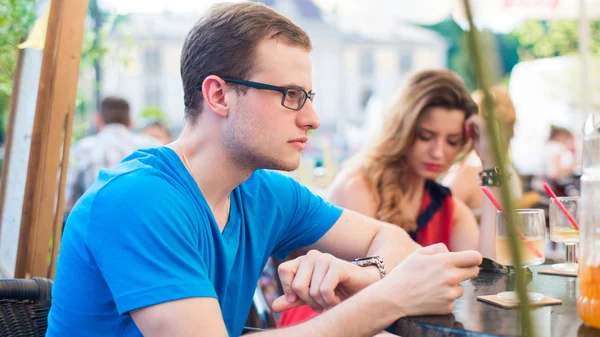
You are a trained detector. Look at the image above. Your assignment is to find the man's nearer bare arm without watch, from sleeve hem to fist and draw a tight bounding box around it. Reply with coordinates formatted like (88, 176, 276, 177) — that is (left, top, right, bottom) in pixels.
(131, 244, 481, 337)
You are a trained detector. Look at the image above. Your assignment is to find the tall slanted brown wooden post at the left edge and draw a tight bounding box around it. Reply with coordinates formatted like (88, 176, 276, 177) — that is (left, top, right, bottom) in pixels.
(15, 0, 88, 278)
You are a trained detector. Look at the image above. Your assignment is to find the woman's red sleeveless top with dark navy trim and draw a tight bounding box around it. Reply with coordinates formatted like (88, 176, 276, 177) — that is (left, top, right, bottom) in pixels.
(277, 180, 454, 327)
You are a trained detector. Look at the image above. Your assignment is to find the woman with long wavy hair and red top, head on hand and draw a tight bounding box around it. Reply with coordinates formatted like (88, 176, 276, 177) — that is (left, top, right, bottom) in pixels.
(279, 70, 495, 326)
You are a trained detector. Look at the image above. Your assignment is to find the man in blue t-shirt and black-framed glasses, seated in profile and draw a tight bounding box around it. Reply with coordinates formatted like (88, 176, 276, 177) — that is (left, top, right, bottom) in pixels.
(47, 2, 481, 337)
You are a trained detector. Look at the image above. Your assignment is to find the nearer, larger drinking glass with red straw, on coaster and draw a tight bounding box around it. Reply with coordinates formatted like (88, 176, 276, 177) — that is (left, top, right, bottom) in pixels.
(496, 208, 546, 302)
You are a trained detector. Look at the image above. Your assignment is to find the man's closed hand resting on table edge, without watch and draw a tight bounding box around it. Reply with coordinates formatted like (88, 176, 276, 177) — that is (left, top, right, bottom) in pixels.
(378, 243, 482, 316)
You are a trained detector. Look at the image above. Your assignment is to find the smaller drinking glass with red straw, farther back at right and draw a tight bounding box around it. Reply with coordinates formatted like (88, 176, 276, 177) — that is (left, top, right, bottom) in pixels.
(550, 197, 581, 272)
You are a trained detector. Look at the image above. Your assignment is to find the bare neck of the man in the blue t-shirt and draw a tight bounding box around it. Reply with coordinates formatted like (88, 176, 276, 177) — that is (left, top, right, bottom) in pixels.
(169, 127, 253, 210)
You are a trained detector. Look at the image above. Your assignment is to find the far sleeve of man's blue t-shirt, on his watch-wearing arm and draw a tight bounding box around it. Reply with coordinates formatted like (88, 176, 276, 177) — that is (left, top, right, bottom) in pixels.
(272, 174, 342, 259)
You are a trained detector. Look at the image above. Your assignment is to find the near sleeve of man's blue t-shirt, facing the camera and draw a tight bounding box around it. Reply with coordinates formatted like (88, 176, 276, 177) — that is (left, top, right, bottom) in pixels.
(85, 173, 217, 314)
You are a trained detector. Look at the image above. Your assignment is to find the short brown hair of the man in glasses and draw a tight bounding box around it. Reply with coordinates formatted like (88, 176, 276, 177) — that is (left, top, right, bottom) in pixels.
(181, 2, 312, 124)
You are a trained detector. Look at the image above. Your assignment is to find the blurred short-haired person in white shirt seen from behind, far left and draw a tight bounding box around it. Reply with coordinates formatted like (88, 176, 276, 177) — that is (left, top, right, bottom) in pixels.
(65, 96, 159, 213)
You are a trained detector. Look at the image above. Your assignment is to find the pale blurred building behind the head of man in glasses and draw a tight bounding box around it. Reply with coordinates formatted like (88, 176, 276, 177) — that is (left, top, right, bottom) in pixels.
(101, 0, 447, 128)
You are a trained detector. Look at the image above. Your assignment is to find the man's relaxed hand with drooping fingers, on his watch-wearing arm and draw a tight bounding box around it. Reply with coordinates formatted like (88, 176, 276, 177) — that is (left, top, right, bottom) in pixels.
(272, 250, 376, 312)
